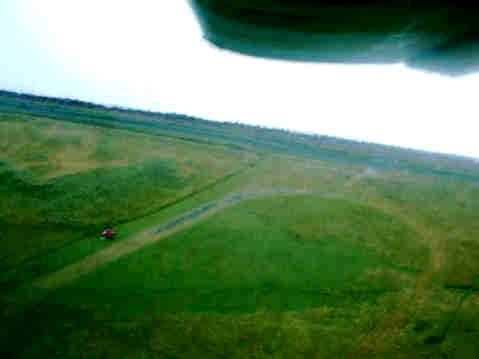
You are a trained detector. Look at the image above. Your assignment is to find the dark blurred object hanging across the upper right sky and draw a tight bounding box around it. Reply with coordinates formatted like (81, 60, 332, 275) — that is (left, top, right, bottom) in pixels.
(190, 0, 479, 76)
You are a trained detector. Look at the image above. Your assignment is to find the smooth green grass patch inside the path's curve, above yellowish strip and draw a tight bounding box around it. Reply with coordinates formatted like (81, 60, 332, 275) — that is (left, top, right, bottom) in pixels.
(51, 197, 427, 317)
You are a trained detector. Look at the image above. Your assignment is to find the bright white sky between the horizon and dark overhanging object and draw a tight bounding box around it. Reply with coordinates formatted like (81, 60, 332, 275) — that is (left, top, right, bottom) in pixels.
(0, 0, 479, 158)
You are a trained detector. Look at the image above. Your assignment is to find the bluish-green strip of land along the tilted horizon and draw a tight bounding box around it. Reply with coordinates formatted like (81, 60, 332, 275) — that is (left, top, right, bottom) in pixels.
(0, 93, 479, 182)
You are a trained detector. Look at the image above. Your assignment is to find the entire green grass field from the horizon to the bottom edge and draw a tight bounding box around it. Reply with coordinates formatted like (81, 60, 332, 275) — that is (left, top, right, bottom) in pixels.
(0, 94, 479, 359)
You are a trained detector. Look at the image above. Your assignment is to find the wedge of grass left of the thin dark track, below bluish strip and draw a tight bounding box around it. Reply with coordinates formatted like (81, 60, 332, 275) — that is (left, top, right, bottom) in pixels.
(0, 117, 253, 282)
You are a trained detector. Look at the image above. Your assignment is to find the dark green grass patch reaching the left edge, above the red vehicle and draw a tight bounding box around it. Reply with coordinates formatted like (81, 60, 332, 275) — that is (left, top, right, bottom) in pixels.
(0, 160, 186, 225)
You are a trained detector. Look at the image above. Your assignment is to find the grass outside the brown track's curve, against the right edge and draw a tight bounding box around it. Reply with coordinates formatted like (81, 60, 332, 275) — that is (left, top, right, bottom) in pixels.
(360, 178, 479, 287)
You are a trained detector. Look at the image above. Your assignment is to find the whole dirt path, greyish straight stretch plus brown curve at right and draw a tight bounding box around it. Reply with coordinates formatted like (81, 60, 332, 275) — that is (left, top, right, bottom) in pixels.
(29, 168, 454, 358)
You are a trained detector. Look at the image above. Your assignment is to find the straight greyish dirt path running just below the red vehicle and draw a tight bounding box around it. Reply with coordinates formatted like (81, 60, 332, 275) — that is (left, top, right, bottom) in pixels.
(33, 189, 313, 289)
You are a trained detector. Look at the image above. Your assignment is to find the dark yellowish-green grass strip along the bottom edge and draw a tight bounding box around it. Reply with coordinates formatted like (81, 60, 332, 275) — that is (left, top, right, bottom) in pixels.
(3, 302, 368, 359)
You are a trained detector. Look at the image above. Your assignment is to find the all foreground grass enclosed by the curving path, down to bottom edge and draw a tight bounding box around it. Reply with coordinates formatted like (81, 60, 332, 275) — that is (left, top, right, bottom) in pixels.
(6, 196, 476, 358)
